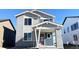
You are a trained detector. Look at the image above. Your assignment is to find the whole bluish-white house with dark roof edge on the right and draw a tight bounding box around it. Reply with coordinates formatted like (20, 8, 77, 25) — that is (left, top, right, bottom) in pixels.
(62, 16, 79, 45)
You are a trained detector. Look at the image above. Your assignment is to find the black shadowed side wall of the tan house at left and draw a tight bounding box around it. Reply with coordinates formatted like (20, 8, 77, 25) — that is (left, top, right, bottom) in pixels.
(3, 27, 16, 48)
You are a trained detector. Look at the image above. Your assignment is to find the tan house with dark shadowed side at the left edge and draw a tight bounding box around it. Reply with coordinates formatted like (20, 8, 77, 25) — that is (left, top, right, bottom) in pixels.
(0, 19, 16, 48)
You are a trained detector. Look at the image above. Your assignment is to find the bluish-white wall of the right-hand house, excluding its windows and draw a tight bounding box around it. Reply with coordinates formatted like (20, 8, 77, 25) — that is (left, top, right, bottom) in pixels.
(62, 18, 79, 44)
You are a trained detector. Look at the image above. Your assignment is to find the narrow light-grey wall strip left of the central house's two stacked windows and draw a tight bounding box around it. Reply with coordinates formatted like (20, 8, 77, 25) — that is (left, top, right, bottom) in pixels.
(16, 16, 23, 46)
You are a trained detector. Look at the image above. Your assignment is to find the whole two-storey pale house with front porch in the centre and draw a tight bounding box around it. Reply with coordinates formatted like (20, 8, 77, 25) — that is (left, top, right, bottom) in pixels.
(16, 10, 63, 48)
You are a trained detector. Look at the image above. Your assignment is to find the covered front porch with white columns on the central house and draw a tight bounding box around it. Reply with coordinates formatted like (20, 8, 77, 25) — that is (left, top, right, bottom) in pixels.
(34, 23, 63, 48)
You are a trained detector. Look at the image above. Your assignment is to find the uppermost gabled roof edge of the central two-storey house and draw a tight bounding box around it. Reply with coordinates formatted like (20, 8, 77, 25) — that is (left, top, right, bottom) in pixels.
(16, 10, 55, 18)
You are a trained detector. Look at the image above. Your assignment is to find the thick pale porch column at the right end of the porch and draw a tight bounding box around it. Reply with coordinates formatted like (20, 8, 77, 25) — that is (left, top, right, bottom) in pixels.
(56, 30, 63, 48)
